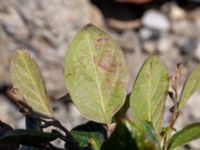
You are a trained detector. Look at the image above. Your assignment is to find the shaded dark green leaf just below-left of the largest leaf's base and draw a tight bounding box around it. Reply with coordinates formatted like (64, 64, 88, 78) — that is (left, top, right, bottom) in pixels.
(70, 121, 106, 150)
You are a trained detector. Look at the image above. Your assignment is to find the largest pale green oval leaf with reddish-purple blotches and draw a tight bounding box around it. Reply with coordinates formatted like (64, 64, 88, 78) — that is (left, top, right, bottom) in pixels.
(65, 24, 129, 126)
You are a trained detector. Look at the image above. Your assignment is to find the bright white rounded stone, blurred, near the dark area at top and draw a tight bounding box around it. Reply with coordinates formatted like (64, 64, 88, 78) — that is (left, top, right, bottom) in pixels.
(142, 10, 170, 31)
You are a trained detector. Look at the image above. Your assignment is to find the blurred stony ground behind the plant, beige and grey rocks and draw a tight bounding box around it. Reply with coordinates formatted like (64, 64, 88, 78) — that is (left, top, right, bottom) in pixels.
(0, 0, 200, 149)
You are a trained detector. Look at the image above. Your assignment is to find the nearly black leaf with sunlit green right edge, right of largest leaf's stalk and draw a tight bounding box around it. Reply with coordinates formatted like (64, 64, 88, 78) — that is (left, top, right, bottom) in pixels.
(101, 120, 144, 150)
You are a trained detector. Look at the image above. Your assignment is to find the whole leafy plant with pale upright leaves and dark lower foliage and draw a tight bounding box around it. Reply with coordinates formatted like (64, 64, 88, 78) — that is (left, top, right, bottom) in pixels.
(0, 24, 200, 150)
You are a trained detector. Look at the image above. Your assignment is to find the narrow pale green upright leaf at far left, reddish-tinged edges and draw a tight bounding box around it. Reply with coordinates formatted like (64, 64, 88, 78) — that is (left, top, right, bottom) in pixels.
(11, 51, 52, 116)
